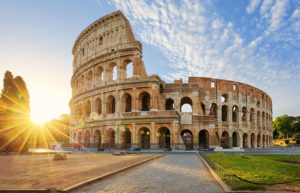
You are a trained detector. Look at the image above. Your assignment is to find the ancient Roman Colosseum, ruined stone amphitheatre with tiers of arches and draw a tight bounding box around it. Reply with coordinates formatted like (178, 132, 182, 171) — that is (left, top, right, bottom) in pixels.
(69, 11, 273, 150)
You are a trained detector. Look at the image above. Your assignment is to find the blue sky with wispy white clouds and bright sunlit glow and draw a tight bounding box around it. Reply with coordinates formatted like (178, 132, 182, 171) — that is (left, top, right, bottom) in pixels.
(0, 0, 300, 122)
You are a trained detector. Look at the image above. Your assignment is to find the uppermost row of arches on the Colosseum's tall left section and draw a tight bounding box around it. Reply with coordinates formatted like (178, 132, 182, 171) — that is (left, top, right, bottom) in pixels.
(73, 59, 136, 92)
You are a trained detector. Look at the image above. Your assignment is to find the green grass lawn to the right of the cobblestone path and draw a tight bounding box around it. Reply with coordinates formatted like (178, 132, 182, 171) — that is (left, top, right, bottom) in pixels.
(206, 154, 300, 190)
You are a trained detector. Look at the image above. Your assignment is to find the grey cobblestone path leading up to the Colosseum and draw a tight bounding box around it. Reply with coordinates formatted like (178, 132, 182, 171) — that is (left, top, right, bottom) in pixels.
(74, 154, 223, 193)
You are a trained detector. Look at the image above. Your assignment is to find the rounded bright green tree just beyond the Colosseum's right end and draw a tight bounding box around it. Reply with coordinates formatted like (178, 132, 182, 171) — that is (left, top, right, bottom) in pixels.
(273, 115, 292, 137)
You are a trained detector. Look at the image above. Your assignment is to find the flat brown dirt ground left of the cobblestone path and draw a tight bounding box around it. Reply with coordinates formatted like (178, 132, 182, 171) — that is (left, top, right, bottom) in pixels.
(0, 153, 158, 189)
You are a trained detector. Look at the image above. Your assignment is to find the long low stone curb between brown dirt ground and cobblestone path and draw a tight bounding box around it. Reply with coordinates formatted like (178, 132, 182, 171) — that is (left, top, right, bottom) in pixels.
(59, 155, 165, 192)
